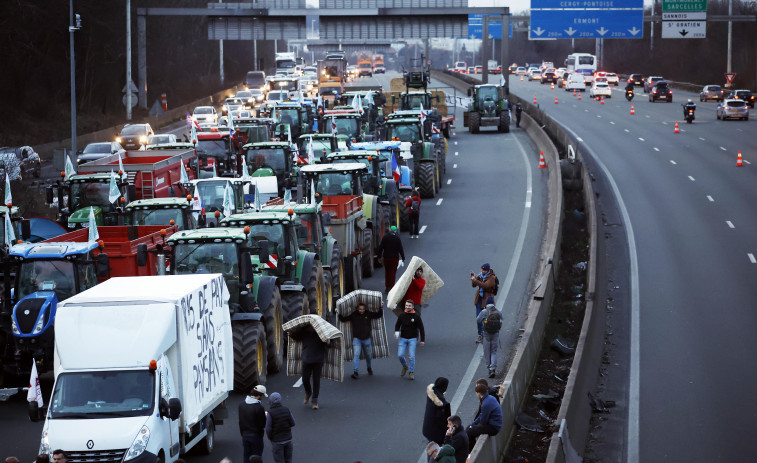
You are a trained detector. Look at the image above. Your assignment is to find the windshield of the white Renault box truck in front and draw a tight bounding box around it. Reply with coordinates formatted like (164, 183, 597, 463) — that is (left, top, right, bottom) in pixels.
(50, 370, 155, 419)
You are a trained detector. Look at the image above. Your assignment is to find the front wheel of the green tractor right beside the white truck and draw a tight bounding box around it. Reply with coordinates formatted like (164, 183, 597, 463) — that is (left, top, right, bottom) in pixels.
(231, 321, 268, 394)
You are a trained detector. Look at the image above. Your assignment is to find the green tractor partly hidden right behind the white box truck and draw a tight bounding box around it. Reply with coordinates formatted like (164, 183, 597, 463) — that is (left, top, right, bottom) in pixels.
(167, 227, 284, 392)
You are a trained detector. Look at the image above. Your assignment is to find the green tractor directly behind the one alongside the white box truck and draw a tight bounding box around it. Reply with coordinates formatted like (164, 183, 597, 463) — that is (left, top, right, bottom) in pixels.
(221, 210, 327, 323)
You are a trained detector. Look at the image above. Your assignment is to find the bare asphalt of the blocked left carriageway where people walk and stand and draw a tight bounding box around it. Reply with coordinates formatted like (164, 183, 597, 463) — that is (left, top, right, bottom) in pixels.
(0, 74, 546, 463)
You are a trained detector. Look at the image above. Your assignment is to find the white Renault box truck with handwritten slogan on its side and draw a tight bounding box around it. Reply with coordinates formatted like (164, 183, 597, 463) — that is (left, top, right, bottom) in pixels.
(30, 274, 234, 463)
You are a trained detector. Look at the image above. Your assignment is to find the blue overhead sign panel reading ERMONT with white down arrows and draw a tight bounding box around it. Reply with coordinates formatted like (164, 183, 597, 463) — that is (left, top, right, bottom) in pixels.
(529, 8, 644, 40)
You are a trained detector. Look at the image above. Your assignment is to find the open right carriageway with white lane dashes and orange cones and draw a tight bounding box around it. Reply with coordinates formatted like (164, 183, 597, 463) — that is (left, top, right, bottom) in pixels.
(511, 75, 757, 462)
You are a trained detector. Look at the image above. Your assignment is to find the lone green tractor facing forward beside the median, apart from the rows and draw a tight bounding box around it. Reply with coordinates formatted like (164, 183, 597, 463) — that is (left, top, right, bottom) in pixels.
(463, 84, 510, 133)
